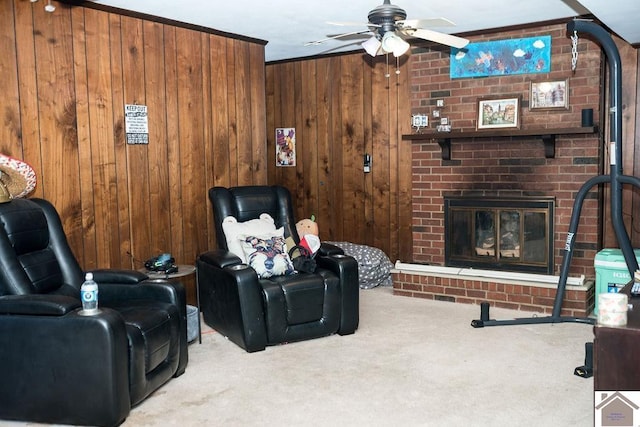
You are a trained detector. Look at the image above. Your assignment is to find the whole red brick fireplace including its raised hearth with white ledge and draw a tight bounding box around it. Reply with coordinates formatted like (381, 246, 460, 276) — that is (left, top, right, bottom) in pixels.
(394, 24, 604, 316)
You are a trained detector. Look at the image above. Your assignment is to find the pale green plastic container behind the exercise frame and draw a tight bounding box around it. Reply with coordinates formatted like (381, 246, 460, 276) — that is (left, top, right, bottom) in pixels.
(593, 249, 640, 316)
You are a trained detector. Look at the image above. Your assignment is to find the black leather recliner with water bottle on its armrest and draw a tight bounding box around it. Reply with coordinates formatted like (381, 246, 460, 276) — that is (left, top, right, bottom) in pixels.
(0, 199, 188, 426)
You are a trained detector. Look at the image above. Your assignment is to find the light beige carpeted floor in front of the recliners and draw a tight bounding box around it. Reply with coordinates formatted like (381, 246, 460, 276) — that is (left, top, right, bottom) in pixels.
(5, 287, 593, 427)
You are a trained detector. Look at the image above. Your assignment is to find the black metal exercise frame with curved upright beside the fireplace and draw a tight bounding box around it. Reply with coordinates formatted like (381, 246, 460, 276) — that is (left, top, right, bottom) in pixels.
(471, 19, 640, 328)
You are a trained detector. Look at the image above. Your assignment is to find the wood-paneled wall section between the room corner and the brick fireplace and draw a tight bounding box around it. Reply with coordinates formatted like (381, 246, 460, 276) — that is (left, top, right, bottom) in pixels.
(266, 52, 411, 261)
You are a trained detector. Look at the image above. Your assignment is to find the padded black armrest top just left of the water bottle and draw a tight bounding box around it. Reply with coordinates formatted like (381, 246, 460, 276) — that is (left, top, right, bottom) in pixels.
(0, 295, 82, 316)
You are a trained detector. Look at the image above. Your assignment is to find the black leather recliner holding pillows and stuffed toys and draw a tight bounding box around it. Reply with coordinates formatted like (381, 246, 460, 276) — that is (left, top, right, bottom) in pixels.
(196, 186, 360, 352)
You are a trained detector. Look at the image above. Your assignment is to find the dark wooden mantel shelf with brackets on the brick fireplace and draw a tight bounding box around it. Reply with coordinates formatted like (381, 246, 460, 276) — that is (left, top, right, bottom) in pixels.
(402, 125, 598, 160)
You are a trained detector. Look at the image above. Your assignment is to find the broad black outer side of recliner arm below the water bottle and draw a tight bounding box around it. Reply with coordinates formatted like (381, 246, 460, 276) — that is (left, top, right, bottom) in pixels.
(0, 308, 131, 426)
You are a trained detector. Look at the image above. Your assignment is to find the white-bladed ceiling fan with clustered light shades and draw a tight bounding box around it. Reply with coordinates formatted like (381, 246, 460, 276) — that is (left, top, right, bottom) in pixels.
(305, 0, 469, 57)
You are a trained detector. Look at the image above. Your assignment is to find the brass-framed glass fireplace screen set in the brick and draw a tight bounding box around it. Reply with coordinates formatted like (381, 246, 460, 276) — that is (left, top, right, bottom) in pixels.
(445, 197, 554, 274)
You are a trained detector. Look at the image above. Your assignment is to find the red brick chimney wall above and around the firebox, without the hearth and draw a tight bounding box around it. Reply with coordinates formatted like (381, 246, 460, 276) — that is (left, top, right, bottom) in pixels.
(402, 23, 606, 278)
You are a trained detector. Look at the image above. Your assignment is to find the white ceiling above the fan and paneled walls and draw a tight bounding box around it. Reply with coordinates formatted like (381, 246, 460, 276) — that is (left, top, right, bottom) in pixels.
(89, 0, 640, 61)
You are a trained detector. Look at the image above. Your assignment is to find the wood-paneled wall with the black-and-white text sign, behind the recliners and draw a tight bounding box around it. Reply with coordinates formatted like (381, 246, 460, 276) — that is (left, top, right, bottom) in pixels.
(0, 0, 267, 300)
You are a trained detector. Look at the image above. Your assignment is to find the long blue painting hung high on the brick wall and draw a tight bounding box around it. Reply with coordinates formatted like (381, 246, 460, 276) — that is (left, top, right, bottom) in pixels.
(449, 36, 551, 79)
